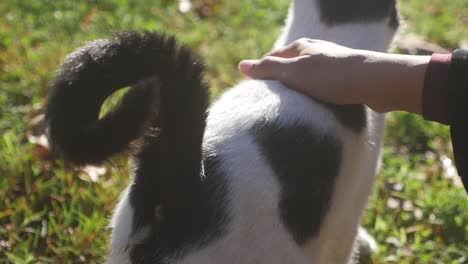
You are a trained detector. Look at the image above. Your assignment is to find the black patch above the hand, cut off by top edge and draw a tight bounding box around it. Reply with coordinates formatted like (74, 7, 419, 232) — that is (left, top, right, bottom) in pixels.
(319, 0, 396, 25)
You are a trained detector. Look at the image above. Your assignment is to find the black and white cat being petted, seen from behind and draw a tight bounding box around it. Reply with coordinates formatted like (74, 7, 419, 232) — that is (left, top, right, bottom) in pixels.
(47, 0, 398, 264)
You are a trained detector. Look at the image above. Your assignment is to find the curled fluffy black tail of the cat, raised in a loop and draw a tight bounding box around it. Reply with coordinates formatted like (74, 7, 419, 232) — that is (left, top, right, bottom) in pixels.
(46, 32, 208, 165)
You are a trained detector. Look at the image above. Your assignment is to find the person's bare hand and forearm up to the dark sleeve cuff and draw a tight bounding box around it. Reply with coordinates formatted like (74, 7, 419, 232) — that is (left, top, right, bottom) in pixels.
(239, 39, 431, 115)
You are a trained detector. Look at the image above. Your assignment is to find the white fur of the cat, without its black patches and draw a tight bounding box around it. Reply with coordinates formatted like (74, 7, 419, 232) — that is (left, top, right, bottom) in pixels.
(109, 0, 393, 264)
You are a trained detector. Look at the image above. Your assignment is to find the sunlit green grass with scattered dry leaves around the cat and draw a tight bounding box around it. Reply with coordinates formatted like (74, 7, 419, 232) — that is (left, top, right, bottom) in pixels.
(0, 0, 468, 263)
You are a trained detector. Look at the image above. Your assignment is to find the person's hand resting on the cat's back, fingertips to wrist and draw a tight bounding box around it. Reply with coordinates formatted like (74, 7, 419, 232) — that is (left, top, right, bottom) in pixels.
(239, 38, 370, 104)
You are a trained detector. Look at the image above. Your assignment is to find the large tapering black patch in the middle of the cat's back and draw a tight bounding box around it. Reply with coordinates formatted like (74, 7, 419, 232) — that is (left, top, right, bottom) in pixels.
(252, 123, 341, 245)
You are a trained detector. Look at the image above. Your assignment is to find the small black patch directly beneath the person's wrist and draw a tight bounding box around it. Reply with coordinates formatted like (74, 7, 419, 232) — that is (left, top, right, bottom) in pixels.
(324, 104, 367, 133)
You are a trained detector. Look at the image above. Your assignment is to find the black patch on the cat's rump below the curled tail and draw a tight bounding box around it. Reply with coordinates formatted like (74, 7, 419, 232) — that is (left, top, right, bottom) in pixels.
(130, 152, 229, 264)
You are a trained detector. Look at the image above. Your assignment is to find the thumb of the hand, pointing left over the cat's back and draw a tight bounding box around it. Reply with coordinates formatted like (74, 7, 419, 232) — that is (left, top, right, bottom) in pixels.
(239, 56, 290, 81)
